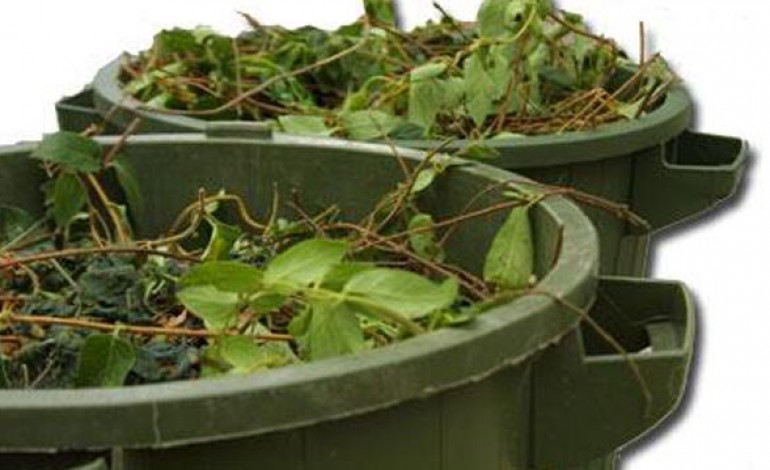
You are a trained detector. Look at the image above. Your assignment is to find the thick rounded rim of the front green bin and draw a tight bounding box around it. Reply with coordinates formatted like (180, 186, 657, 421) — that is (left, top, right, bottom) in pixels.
(0, 134, 598, 451)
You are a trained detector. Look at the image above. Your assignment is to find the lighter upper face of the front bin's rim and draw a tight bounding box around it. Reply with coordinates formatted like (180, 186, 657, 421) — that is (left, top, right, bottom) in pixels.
(0, 134, 598, 448)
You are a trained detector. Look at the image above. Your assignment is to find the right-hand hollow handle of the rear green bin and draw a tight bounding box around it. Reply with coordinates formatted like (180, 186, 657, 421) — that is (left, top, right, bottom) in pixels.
(632, 131, 749, 230)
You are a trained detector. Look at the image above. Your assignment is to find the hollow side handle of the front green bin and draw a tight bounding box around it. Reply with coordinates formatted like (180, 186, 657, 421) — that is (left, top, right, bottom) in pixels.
(532, 277, 695, 468)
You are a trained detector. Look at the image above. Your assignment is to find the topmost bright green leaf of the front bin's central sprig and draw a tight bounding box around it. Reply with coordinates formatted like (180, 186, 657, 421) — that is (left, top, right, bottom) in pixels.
(265, 239, 348, 286)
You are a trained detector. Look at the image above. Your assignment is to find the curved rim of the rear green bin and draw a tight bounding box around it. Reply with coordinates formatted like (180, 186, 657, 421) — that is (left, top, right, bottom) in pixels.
(91, 53, 692, 168)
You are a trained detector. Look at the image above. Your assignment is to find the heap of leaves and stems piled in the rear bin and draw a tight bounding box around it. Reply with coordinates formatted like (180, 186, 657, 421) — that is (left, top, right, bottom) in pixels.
(122, 0, 676, 141)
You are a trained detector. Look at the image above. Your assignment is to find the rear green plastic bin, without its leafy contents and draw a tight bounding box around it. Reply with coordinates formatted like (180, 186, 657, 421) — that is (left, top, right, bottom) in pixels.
(57, 60, 747, 276)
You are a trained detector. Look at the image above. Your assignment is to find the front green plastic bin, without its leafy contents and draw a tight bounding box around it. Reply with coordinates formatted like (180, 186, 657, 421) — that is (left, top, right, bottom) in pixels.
(0, 130, 694, 470)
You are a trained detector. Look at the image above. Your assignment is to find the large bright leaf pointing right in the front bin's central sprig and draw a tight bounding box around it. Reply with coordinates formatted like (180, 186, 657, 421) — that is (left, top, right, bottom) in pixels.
(344, 269, 459, 320)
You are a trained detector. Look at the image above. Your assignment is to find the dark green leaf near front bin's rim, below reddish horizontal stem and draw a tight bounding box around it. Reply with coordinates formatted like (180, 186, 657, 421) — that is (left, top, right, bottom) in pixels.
(75, 335, 136, 388)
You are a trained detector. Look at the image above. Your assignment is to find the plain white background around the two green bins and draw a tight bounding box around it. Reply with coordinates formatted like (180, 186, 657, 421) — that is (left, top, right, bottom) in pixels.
(0, 0, 770, 470)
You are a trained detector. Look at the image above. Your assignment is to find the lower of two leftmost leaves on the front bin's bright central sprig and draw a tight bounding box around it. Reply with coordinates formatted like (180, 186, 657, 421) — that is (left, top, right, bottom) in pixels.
(177, 285, 240, 330)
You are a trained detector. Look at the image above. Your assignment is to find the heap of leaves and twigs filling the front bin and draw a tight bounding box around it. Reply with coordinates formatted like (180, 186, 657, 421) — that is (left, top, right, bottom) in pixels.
(0, 132, 537, 389)
